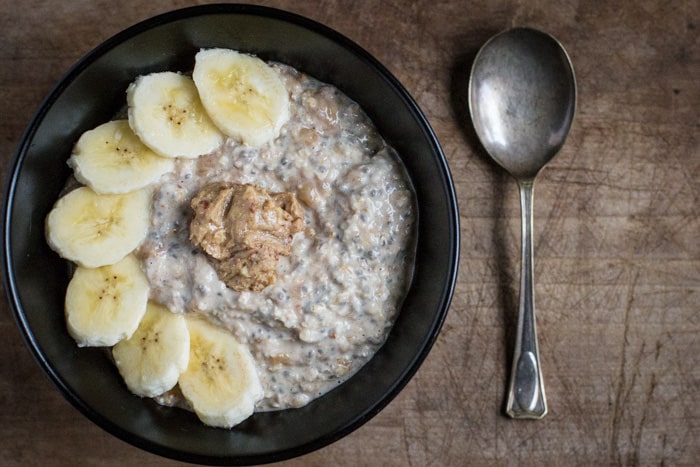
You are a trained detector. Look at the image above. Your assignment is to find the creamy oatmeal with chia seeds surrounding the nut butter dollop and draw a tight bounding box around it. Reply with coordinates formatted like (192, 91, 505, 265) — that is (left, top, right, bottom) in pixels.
(138, 64, 416, 410)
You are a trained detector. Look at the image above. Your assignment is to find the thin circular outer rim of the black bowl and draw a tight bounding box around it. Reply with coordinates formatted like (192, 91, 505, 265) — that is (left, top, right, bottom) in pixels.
(0, 3, 460, 465)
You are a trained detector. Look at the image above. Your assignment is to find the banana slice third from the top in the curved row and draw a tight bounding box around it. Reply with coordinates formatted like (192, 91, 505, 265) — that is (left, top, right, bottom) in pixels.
(68, 120, 174, 194)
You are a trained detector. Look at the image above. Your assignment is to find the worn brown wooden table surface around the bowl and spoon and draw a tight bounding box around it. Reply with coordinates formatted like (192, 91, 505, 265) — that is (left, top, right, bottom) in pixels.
(0, 0, 700, 466)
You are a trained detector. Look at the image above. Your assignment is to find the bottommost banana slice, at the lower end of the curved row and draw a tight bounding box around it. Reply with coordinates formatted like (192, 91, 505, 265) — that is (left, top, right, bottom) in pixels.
(179, 318, 263, 428)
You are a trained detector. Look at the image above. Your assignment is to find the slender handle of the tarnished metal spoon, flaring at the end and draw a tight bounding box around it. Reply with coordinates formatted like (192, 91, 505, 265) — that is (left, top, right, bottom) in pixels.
(506, 180, 547, 419)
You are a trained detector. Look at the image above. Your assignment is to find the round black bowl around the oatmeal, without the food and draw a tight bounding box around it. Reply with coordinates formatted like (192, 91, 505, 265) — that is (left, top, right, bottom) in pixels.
(3, 4, 459, 465)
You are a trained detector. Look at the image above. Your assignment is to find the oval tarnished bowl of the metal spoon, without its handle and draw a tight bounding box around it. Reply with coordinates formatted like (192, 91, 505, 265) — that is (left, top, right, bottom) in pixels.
(469, 28, 576, 179)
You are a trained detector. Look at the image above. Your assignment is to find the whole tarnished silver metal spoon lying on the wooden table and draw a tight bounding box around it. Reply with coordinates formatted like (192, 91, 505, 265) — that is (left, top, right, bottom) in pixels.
(469, 28, 576, 418)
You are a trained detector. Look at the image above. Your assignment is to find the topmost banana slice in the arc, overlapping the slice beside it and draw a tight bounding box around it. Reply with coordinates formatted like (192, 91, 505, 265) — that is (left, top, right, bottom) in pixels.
(192, 49, 289, 146)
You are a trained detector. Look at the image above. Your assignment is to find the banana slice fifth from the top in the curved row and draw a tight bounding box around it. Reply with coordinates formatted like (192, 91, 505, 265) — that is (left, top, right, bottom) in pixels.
(65, 255, 150, 347)
